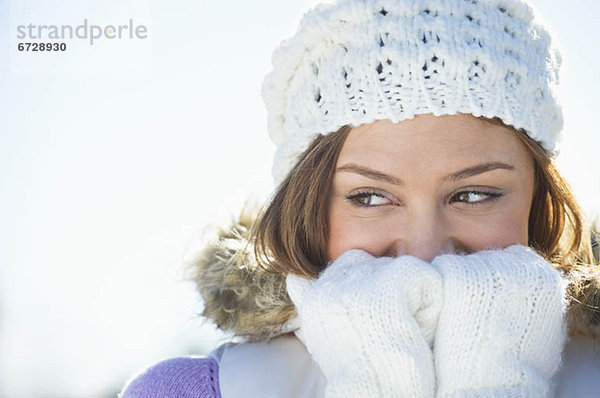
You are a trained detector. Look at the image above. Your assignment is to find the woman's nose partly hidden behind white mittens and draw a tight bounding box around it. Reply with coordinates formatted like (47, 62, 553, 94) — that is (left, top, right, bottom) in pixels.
(388, 210, 466, 263)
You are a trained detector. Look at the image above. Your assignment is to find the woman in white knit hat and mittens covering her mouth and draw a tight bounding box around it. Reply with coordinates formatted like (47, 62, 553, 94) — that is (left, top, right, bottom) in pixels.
(122, 0, 600, 397)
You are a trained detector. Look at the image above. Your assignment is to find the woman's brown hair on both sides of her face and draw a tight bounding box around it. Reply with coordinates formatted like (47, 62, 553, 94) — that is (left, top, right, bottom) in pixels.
(250, 118, 594, 278)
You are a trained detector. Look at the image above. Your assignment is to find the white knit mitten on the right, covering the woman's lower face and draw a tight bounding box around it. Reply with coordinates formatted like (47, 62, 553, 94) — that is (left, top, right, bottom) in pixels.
(432, 245, 566, 398)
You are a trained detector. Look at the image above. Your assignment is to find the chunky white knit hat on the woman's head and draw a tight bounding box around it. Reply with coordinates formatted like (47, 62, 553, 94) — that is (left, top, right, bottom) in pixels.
(262, 0, 563, 183)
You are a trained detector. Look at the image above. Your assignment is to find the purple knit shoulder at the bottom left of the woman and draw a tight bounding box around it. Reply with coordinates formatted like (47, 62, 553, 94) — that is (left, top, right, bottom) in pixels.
(119, 357, 221, 398)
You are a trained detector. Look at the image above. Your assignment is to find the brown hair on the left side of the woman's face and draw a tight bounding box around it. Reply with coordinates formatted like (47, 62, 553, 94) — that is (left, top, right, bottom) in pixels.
(250, 125, 350, 277)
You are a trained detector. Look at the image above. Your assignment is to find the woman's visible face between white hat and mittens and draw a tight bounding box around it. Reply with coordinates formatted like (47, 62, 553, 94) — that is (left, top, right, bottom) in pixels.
(328, 114, 534, 262)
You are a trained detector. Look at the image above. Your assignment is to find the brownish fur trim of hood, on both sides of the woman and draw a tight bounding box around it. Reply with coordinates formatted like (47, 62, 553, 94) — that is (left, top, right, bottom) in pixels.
(186, 206, 600, 341)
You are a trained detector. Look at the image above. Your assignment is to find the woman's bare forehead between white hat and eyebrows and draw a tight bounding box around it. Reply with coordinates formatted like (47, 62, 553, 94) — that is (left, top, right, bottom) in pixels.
(338, 114, 530, 169)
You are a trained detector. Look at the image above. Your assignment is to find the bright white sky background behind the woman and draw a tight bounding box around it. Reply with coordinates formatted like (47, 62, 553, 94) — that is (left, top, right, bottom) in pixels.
(0, 0, 600, 397)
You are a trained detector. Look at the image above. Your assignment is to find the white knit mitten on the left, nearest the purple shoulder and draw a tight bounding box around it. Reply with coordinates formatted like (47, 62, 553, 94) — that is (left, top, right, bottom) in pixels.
(286, 250, 443, 398)
